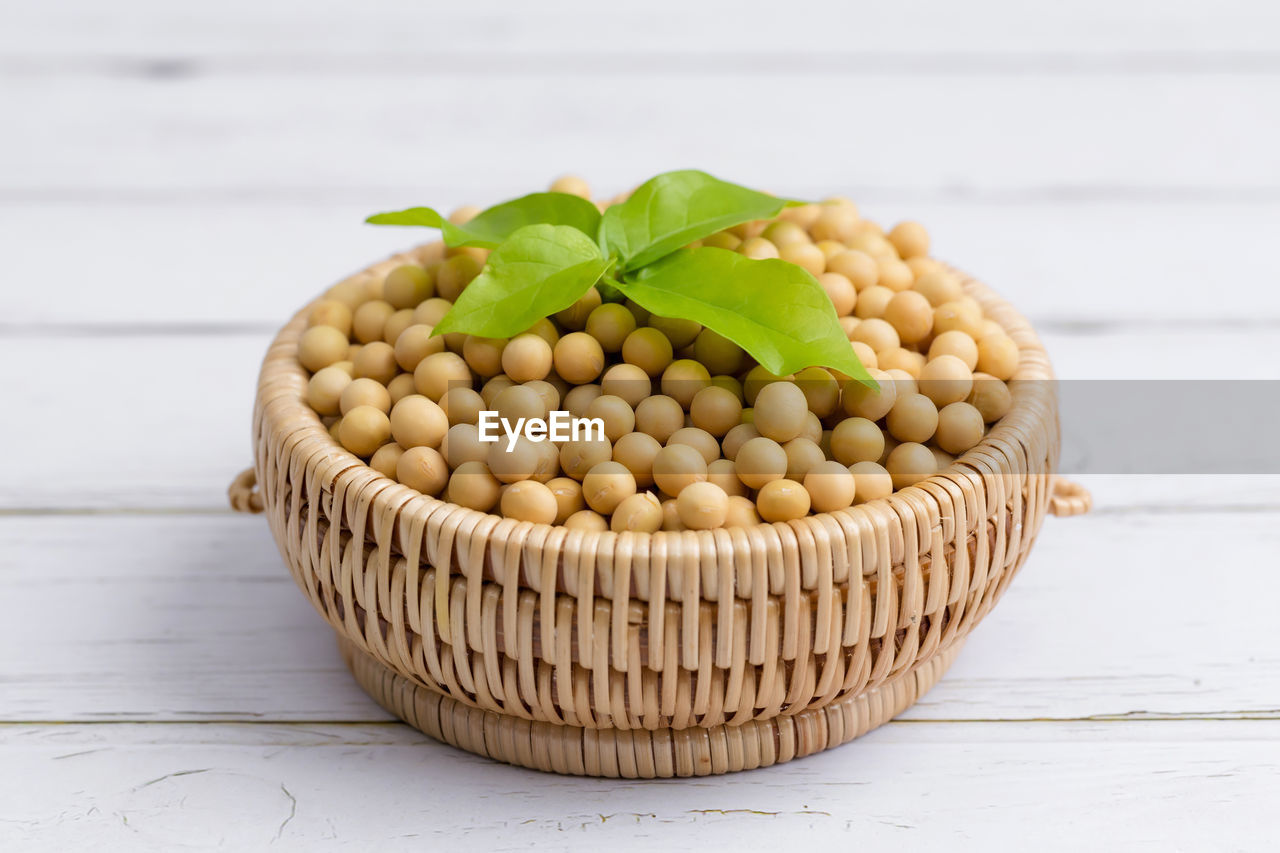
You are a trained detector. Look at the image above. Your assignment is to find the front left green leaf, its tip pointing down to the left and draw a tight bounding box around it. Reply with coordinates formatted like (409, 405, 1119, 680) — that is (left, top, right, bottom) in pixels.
(435, 225, 609, 338)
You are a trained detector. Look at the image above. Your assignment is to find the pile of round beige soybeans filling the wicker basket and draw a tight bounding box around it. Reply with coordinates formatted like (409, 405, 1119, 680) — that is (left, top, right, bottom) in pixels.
(298, 178, 1019, 532)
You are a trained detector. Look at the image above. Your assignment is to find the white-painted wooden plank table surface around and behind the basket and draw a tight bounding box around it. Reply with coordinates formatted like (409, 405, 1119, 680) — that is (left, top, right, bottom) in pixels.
(0, 0, 1280, 850)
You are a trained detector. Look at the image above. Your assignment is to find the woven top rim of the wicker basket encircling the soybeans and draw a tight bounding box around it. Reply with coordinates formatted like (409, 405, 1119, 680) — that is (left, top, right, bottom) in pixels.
(255, 243, 1057, 556)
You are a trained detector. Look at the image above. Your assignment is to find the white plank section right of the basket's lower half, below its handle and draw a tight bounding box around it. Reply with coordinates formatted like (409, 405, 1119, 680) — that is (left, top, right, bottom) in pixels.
(909, 507, 1280, 719)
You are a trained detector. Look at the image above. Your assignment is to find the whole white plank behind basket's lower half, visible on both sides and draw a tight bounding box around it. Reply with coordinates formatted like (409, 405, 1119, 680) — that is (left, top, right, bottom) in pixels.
(0, 507, 1280, 722)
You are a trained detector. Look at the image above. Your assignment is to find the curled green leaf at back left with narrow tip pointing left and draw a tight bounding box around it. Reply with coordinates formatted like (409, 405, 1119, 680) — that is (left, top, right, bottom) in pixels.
(365, 192, 600, 248)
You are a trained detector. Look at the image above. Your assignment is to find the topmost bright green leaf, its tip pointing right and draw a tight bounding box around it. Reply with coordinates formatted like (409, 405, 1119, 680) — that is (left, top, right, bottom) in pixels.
(600, 169, 788, 270)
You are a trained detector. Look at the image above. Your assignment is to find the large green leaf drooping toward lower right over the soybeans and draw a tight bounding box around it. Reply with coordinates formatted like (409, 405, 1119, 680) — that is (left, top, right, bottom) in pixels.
(621, 247, 876, 387)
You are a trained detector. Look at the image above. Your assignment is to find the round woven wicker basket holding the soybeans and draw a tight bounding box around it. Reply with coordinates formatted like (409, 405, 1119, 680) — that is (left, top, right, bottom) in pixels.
(230, 245, 1089, 777)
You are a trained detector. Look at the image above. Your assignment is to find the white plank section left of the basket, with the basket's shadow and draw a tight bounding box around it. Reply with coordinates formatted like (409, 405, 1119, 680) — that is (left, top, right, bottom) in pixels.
(0, 515, 388, 720)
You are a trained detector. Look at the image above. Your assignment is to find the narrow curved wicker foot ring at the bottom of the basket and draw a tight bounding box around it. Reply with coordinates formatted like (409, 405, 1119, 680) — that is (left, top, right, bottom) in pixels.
(338, 638, 963, 779)
